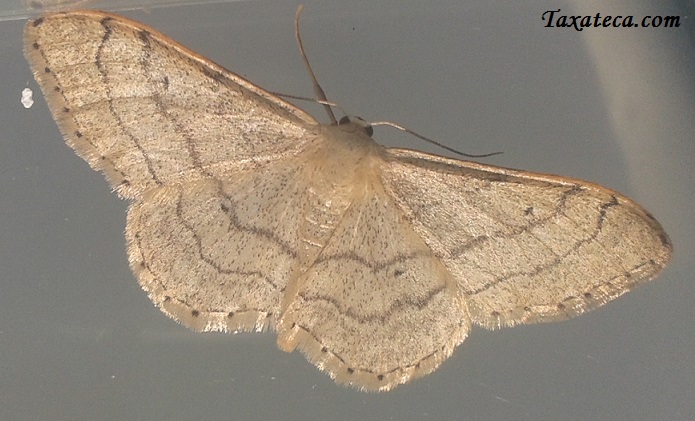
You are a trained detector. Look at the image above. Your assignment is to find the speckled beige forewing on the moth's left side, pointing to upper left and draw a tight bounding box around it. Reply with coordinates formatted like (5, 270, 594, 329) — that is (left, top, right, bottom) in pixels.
(25, 11, 317, 199)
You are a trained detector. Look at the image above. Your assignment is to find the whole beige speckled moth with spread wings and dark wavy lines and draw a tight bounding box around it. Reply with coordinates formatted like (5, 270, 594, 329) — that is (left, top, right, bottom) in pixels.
(25, 11, 672, 391)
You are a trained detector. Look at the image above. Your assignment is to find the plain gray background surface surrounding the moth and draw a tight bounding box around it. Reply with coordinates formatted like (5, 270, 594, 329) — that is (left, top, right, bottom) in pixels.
(0, 1, 695, 420)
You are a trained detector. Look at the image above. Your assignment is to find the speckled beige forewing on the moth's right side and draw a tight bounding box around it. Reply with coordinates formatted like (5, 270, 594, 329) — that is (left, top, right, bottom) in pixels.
(383, 149, 672, 328)
